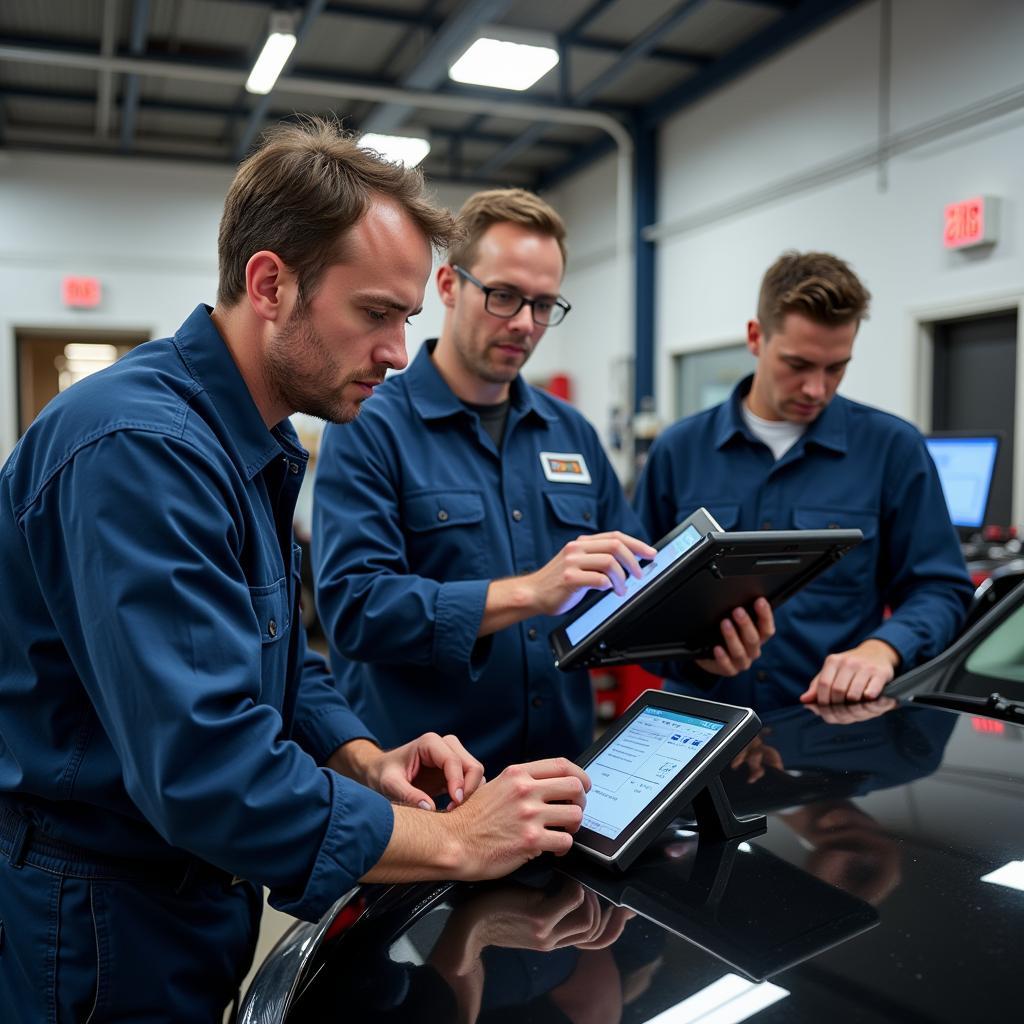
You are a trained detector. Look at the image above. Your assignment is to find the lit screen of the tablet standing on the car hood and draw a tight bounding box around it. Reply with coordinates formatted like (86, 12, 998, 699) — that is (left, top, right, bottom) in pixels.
(583, 708, 725, 839)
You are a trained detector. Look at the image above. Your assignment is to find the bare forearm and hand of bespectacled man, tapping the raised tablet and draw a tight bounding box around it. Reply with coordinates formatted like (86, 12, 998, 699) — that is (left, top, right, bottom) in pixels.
(477, 530, 657, 637)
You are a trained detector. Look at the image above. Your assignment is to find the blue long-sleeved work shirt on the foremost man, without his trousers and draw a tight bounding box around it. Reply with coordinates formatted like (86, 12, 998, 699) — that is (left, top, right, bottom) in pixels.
(0, 306, 393, 920)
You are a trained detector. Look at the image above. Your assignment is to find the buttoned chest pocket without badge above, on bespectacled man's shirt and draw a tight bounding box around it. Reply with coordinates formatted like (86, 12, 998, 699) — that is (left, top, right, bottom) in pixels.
(402, 489, 488, 581)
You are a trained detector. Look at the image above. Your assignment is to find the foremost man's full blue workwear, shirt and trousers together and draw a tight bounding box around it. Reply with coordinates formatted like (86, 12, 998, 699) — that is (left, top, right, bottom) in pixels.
(0, 306, 393, 1022)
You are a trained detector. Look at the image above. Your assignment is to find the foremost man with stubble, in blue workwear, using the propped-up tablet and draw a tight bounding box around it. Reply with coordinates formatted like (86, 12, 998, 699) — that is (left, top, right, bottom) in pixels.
(0, 120, 587, 1022)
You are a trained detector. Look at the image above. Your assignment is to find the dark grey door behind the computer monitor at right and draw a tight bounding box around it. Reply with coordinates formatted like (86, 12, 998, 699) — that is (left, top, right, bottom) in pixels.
(932, 310, 1017, 525)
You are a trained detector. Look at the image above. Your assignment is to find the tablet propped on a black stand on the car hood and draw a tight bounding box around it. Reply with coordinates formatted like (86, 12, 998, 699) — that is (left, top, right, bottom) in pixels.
(573, 690, 765, 869)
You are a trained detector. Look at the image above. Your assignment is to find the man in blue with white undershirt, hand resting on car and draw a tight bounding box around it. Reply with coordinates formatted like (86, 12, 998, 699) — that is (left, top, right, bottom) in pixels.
(635, 252, 972, 709)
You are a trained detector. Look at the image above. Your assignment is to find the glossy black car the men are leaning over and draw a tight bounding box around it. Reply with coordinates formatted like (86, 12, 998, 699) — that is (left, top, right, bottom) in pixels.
(239, 587, 1024, 1024)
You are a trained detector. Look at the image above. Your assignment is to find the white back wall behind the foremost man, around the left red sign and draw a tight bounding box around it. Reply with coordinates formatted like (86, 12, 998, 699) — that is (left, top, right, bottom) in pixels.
(0, 153, 468, 461)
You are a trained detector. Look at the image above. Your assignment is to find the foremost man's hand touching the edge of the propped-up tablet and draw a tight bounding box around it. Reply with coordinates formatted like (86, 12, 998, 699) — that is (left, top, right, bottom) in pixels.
(444, 758, 590, 880)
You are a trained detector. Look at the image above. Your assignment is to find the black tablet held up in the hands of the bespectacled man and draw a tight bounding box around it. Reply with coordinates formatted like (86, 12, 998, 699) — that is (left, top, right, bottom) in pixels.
(550, 508, 863, 671)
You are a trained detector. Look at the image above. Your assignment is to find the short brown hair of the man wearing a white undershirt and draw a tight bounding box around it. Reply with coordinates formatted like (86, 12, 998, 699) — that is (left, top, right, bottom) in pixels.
(758, 250, 871, 338)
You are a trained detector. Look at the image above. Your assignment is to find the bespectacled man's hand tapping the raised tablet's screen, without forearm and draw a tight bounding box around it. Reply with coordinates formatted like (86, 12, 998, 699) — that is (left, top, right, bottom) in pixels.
(525, 530, 657, 615)
